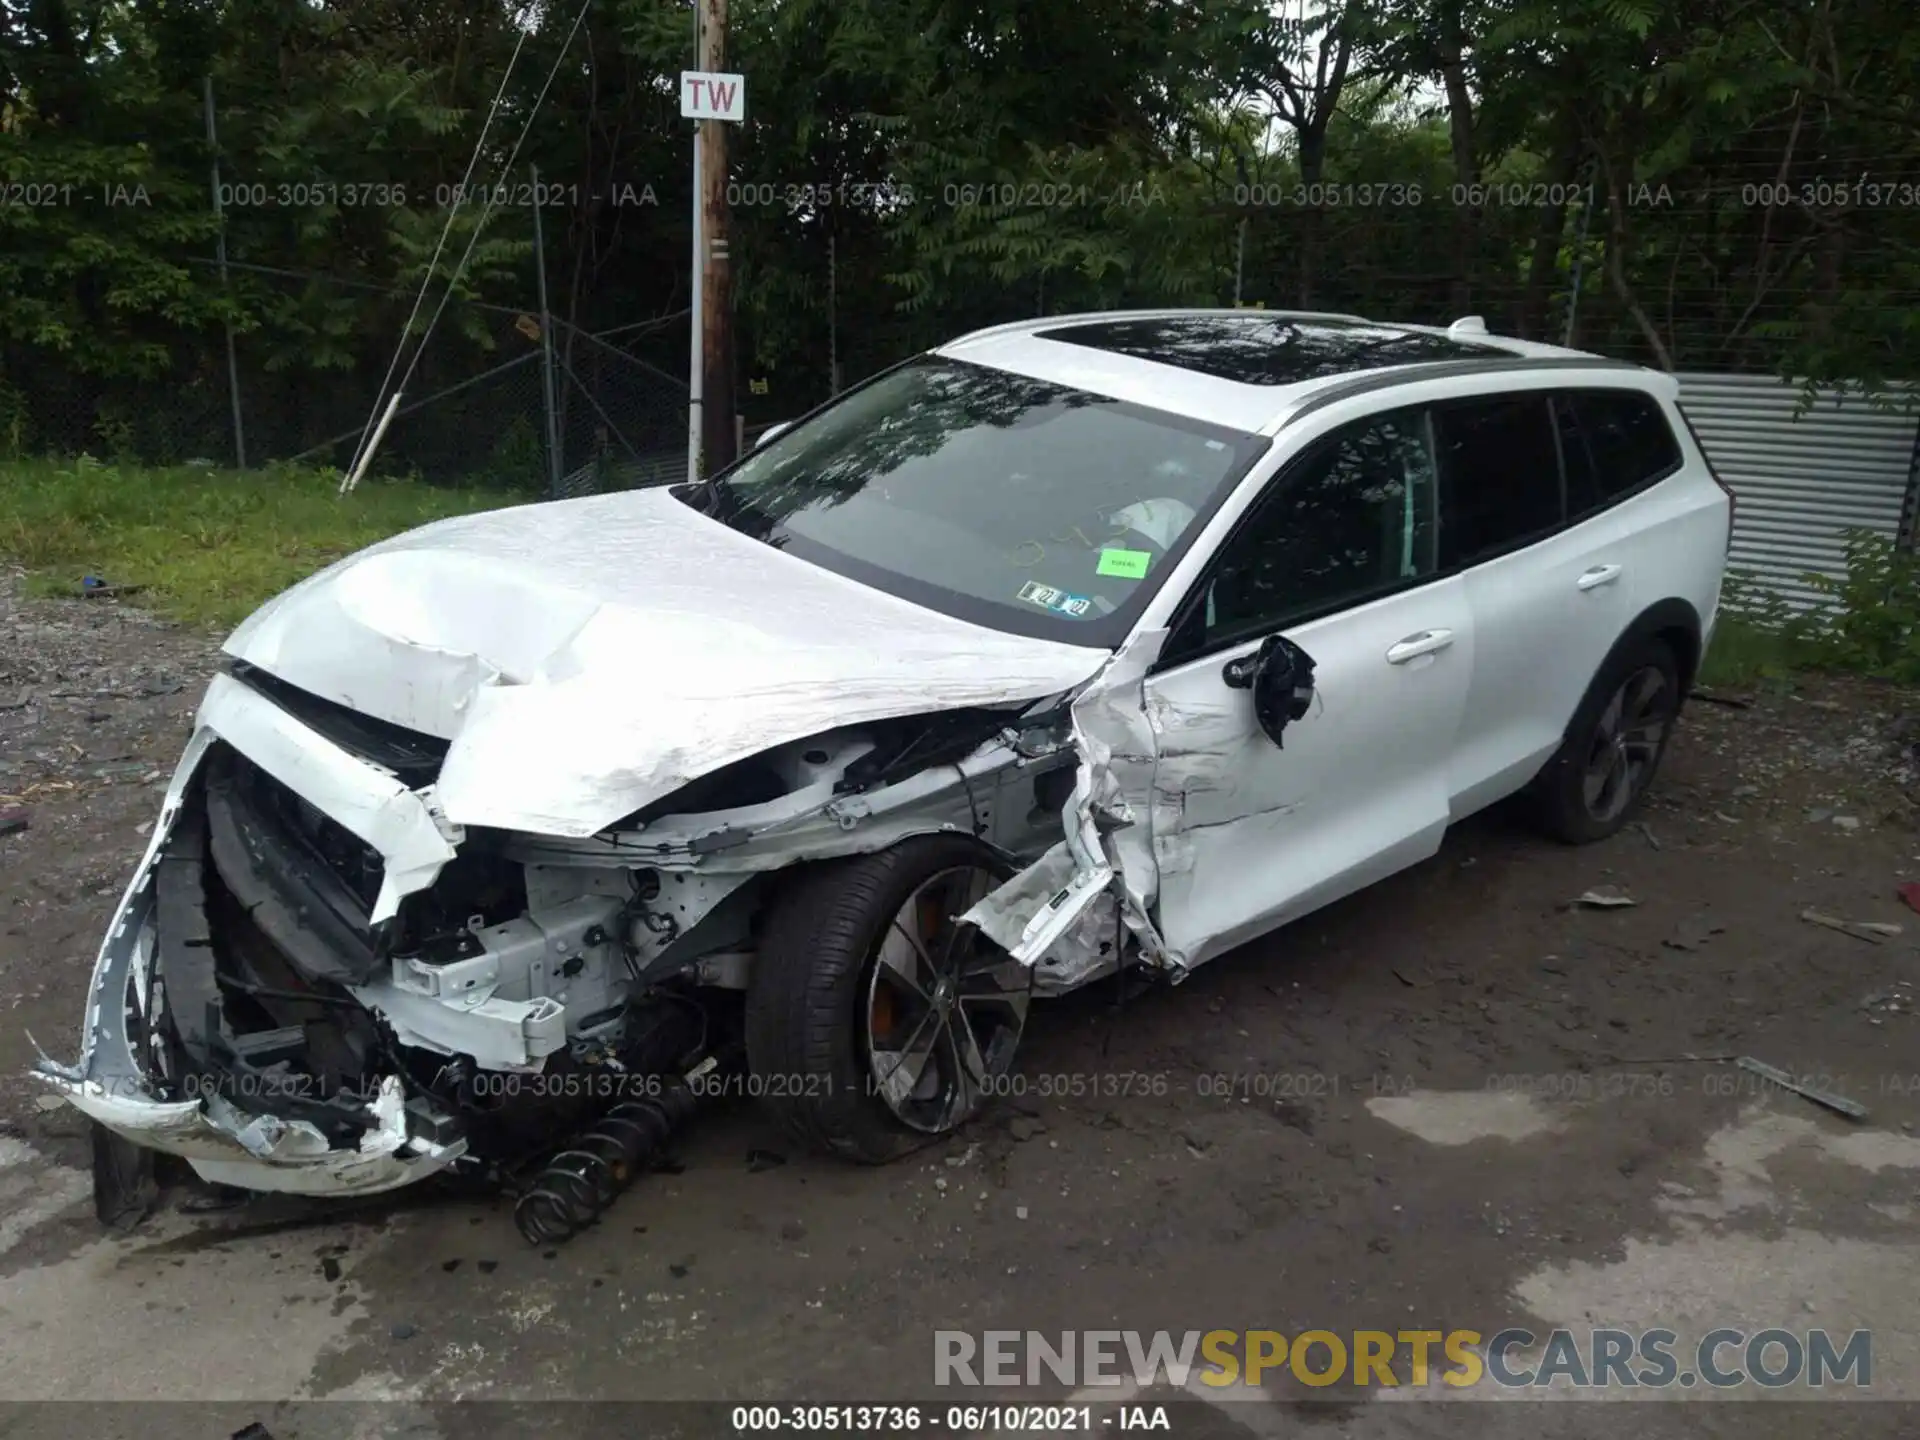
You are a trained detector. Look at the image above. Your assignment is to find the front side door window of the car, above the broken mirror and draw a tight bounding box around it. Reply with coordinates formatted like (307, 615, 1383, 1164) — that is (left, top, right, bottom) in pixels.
(1173, 409, 1434, 653)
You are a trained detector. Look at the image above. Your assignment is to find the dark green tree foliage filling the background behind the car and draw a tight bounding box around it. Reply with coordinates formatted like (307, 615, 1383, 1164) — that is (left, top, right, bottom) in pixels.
(0, 0, 1920, 462)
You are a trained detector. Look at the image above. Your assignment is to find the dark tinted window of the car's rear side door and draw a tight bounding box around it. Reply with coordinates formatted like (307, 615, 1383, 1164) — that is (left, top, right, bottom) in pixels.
(1434, 403, 1561, 566)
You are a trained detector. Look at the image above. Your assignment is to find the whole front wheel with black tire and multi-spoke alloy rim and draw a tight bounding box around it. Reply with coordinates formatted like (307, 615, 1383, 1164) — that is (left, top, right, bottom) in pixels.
(747, 835, 1033, 1164)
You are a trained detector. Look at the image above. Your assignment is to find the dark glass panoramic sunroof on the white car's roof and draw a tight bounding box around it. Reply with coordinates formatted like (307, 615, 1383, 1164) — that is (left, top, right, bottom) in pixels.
(1035, 313, 1503, 386)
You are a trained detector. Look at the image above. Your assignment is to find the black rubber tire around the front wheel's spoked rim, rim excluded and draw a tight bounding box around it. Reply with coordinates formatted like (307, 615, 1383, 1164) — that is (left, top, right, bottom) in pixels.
(747, 835, 1031, 1165)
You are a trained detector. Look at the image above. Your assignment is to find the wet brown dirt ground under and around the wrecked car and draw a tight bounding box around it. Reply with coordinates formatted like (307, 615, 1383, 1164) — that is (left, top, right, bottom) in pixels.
(0, 576, 1920, 1440)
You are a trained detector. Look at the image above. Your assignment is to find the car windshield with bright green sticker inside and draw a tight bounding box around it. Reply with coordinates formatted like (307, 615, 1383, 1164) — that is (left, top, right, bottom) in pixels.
(712, 357, 1265, 645)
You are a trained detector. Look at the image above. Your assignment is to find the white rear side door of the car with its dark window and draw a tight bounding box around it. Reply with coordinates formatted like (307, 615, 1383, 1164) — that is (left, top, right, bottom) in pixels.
(1434, 390, 1636, 818)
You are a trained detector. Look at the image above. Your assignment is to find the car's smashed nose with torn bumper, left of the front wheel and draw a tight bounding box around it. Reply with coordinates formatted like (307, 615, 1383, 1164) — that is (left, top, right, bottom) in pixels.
(38, 666, 702, 1194)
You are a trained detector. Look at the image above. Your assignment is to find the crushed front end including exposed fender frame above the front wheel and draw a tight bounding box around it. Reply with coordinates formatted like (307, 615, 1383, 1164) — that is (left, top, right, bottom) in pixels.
(38, 662, 1117, 1219)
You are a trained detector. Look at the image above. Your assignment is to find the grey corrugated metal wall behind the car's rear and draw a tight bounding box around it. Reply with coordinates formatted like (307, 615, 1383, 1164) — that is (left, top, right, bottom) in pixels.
(1678, 374, 1920, 605)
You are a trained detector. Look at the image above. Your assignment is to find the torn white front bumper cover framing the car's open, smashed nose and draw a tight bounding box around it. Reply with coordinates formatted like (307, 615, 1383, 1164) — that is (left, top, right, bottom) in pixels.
(36, 676, 465, 1194)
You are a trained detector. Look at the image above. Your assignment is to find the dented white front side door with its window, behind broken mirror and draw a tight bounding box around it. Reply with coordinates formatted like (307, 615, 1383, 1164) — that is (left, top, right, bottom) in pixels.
(1144, 409, 1475, 964)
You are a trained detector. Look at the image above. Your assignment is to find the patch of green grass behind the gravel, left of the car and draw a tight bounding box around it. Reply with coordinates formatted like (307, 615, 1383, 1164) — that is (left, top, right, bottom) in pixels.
(0, 459, 528, 626)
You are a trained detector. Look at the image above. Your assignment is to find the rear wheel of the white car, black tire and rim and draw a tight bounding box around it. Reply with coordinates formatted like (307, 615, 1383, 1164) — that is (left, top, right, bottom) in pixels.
(1534, 636, 1682, 845)
